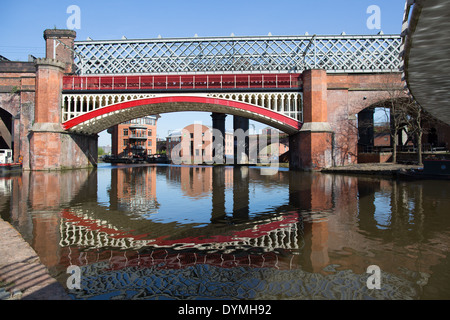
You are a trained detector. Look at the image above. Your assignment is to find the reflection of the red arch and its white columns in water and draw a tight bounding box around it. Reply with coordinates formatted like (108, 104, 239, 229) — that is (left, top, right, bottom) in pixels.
(60, 210, 301, 253)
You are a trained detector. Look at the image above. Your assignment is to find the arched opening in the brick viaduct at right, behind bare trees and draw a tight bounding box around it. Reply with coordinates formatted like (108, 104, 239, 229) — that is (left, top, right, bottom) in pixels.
(358, 97, 450, 164)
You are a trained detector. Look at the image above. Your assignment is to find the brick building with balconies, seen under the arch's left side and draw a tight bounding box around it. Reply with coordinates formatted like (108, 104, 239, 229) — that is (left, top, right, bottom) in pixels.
(108, 116, 157, 157)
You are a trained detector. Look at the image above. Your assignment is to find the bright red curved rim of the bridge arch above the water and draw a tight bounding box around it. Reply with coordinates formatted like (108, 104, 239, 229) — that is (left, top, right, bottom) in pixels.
(63, 96, 301, 132)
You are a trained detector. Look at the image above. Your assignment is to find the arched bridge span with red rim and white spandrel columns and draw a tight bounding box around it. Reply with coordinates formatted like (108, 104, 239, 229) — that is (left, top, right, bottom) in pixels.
(63, 93, 301, 134)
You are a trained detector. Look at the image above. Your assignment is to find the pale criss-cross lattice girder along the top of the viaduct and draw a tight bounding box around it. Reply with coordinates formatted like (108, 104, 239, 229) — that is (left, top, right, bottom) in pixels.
(74, 35, 401, 75)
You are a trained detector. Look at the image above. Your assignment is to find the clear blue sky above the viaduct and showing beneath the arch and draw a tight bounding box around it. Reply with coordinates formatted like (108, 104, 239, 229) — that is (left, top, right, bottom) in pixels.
(0, 0, 405, 145)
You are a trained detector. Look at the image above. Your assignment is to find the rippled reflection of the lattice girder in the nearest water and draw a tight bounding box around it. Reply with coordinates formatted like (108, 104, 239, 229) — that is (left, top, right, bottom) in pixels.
(71, 257, 417, 300)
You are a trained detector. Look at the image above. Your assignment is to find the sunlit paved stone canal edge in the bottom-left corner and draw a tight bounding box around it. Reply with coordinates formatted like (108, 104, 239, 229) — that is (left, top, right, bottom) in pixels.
(0, 218, 70, 300)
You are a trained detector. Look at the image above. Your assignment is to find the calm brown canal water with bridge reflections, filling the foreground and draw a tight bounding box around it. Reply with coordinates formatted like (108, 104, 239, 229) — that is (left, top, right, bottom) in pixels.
(0, 164, 450, 300)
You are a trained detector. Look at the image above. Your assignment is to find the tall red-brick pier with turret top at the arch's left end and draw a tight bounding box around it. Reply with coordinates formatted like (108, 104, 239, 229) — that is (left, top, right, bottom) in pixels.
(29, 29, 98, 170)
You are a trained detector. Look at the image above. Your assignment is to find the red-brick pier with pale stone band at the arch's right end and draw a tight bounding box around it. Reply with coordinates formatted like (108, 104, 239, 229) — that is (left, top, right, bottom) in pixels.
(289, 69, 333, 170)
